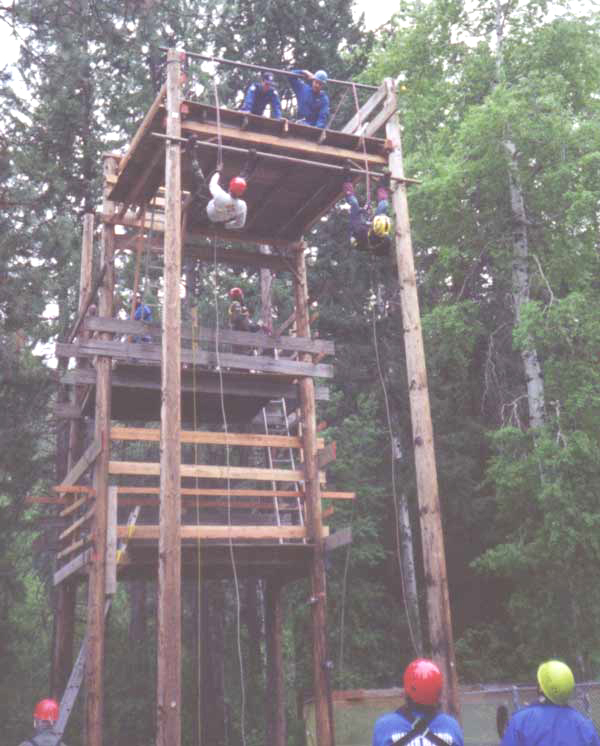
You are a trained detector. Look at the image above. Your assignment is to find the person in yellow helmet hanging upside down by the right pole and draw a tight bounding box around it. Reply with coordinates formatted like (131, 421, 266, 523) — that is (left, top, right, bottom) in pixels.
(342, 169, 392, 256)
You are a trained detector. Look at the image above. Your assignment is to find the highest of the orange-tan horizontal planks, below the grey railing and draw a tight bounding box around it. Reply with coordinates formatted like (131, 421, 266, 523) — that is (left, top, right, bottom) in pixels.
(110, 427, 325, 448)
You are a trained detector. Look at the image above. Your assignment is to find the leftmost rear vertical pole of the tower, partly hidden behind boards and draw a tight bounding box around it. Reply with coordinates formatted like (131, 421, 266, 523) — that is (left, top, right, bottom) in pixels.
(50, 213, 94, 699)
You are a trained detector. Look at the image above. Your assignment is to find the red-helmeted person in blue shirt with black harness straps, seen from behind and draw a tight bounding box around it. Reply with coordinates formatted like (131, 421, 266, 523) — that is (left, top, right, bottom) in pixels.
(373, 658, 464, 746)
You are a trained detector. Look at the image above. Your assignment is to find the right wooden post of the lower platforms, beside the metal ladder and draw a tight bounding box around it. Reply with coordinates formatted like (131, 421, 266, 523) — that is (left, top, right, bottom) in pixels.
(294, 246, 334, 746)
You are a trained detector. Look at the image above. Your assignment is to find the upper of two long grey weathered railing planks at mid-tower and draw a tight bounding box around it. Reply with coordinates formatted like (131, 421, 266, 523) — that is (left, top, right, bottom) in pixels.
(85, 316, 335, 355)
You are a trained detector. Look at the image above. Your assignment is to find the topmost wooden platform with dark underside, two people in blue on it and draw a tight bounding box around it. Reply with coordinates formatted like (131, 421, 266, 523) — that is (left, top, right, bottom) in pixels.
(110, 94, 387, 245)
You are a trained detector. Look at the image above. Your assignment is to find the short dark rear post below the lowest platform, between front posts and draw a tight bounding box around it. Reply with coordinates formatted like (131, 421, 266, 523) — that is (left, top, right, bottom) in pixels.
(265, 579, 287, 746)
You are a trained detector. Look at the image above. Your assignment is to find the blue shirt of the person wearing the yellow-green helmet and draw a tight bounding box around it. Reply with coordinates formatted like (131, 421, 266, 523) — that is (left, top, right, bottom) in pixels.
(502, 702, 600, 746)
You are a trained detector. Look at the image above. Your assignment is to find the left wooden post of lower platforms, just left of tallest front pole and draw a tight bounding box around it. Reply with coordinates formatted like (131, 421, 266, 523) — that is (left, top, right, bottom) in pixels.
(85, 157, 117, 746)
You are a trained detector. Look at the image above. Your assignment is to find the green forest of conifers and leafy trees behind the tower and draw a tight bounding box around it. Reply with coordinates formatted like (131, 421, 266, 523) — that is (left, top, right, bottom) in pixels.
(0, 0, 600, 746)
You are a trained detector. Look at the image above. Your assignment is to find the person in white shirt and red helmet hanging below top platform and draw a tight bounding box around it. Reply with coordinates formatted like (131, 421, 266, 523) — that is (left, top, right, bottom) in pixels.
(188, 136, 258, 230)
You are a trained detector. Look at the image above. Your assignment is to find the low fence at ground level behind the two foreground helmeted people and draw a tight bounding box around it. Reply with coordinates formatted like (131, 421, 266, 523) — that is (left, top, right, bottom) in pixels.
(304, 682, 600, 746)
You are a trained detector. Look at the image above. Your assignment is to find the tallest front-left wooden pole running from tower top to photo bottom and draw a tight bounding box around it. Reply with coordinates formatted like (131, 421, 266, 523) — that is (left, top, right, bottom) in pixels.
(156, 49, 181, 746)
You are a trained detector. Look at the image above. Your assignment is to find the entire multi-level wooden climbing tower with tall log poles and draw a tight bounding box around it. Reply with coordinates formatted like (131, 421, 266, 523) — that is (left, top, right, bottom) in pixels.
(48, 50, 454, 746)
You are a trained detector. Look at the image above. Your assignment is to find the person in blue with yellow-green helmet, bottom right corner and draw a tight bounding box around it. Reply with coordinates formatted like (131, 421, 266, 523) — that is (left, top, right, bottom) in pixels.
(502, 660, 600, 746)
